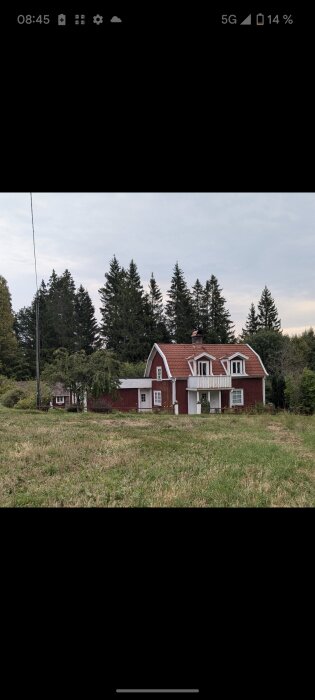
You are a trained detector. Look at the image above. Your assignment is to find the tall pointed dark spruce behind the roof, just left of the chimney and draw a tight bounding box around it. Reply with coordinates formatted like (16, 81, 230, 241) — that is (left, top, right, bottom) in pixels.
(166, 262, 194, 343)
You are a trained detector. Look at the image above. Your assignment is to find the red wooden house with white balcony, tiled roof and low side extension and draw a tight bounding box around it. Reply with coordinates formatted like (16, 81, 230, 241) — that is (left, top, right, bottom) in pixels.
(88, 331, 267, 414)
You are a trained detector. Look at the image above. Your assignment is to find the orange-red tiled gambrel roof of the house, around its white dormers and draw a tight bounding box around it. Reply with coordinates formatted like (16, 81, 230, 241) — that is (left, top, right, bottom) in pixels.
(145, 343, 268, 378)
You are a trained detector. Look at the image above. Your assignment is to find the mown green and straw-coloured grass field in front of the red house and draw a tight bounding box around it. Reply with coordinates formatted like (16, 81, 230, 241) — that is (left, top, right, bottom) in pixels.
(0, 408, 315, 507)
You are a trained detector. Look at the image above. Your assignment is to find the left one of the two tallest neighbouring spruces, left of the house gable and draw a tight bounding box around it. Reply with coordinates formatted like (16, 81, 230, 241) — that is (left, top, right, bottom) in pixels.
(99, 255, 126, 356)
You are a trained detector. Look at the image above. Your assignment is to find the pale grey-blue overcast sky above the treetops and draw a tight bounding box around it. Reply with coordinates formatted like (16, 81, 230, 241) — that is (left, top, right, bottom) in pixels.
(0, 193, 315, 333)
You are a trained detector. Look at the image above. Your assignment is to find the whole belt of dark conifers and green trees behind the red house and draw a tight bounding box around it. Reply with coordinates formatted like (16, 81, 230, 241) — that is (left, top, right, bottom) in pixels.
(0, 255, 315, 414)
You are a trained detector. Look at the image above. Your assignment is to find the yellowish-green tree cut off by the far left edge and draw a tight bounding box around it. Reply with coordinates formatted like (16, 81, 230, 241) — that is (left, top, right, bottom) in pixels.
(0, 275, 18, 376)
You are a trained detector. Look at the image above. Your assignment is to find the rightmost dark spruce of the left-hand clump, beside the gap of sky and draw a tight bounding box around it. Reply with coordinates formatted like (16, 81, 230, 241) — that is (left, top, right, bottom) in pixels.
(74, 284, 99, 355)
